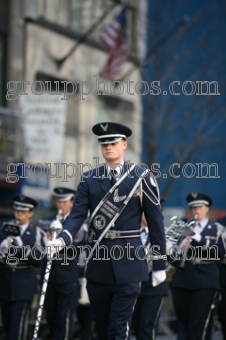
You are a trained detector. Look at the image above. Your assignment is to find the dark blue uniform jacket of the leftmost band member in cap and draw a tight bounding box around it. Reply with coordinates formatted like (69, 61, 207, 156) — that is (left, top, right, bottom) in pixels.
(0, 225, 45, 301)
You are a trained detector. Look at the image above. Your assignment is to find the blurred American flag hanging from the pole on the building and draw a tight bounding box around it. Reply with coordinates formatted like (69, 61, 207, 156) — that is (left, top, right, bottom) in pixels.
(99, 5, 127, 79)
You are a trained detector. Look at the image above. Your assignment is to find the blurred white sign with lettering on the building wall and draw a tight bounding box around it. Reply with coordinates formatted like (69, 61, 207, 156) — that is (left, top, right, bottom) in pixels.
(20, 93, 67, 163)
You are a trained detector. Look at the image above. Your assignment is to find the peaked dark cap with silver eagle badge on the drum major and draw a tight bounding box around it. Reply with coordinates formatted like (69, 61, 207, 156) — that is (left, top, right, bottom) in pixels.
(92, 122, 132, 144)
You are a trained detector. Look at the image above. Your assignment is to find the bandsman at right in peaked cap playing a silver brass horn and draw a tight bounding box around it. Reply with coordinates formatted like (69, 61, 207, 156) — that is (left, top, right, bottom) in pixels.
(169, 192, 220, 340)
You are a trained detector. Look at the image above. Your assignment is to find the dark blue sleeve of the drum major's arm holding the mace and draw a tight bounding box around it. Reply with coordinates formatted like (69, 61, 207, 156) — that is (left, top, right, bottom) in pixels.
(59, 181, 89, 246)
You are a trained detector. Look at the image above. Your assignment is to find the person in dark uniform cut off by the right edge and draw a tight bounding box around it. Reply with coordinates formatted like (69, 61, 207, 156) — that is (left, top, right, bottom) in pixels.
(216, 216, 226, 340)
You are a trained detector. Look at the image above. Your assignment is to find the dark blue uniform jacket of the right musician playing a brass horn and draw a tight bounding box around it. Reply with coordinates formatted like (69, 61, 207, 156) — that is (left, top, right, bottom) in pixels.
(168, 221, 221, 290)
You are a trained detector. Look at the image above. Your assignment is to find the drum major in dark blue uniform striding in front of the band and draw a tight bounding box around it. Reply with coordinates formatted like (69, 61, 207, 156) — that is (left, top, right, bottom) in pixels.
(46, 122, 166, 340)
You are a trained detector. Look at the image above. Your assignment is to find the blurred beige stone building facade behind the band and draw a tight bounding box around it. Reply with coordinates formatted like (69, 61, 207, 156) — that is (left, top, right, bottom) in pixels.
(0, 0, 147, 219)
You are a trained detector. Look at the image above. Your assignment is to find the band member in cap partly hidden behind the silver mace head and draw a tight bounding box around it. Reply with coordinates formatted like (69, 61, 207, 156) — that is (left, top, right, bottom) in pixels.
(40, 187, 83, 340)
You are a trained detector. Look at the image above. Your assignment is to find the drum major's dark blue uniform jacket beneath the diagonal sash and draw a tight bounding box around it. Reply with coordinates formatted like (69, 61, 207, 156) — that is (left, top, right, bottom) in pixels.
(59, 164, 165, 284)
